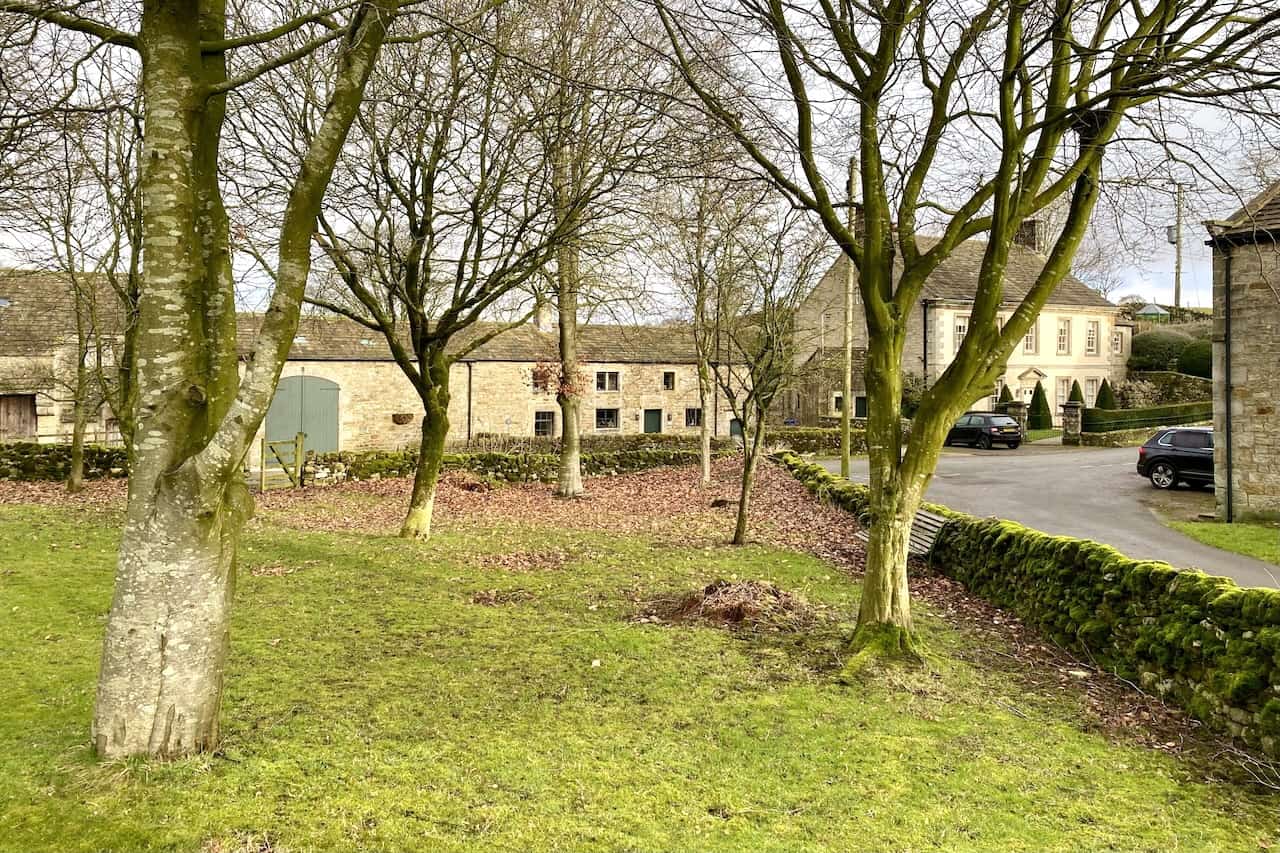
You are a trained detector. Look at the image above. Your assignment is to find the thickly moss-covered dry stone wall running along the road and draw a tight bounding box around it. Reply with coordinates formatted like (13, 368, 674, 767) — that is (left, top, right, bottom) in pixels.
(774, 453, 1280, 757)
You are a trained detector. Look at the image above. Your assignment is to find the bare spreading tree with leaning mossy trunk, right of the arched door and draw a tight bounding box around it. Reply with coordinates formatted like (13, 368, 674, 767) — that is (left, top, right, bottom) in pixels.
(299, 6, 590, 538)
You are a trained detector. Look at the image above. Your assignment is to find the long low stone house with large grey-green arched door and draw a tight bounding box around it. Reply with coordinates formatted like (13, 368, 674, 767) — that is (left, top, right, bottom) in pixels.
(239, 315, 737, 452)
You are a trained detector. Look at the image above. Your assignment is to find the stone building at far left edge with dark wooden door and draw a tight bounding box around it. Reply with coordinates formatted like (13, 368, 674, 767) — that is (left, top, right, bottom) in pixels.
(0, 270, 120, 443)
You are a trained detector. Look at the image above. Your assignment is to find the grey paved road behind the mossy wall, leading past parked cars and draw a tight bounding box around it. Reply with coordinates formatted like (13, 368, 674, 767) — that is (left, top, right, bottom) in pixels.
(822, 444, 1280, 587)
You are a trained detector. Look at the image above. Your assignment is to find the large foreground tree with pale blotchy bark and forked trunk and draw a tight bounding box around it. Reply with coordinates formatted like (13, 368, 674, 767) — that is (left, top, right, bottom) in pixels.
(0, 0, 402, 757)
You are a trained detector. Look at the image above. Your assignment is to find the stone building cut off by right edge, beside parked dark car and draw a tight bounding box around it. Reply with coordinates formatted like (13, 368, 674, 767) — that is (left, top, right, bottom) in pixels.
(1206, 182, 1280, 521)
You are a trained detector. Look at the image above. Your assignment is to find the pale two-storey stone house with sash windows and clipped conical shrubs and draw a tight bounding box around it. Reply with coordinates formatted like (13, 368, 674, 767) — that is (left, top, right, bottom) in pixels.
(785, 228, 1133, 425)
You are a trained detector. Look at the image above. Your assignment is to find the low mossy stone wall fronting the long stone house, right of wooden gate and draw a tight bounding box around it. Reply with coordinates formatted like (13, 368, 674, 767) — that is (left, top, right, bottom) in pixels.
(311, 448, 731, 483)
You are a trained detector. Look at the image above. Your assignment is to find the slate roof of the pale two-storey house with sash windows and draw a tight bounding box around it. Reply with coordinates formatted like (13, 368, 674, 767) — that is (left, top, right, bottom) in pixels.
(836, 236, 1115, 307)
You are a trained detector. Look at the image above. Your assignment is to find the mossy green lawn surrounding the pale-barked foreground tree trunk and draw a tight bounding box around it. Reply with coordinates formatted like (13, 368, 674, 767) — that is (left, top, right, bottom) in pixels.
(0, 507, 1276, 853)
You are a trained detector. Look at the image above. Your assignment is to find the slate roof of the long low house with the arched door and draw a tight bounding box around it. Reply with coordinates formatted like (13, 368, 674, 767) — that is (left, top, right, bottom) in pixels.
(238, 314, 698, 364)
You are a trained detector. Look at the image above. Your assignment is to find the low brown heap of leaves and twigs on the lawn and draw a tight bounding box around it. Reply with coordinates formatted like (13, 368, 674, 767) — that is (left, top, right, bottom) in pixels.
(634, 580, 818, 631)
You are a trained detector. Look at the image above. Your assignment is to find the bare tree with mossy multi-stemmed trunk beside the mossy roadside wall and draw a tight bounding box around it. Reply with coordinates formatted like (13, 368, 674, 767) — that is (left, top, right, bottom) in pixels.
(655, 0, 1280, 654)
